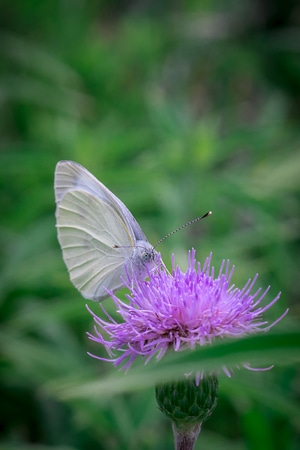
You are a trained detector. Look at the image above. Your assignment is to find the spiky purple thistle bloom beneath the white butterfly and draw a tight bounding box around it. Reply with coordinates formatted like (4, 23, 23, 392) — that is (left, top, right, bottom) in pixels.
(88, 249, 288, 376)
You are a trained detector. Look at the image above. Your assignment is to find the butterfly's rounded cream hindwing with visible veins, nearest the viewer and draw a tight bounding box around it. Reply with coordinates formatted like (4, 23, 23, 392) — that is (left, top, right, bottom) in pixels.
(56, 189, 135, 301)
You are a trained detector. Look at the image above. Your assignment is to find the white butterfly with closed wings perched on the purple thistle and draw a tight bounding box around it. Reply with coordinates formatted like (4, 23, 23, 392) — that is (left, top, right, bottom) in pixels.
(54, 161, 158, 301)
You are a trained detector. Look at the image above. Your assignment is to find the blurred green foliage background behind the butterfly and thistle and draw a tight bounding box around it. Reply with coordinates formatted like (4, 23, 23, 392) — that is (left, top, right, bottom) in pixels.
(0, 0, 300, 450)
